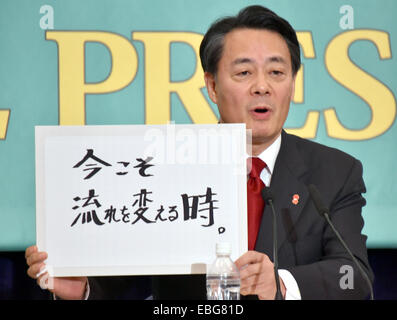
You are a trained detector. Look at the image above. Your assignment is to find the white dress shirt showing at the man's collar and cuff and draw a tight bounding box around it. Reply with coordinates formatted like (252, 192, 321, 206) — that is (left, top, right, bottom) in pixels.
(248, 134, 302, 300)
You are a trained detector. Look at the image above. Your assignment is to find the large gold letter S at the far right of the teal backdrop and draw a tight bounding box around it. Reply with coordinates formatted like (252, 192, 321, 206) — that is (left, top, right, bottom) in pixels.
(324, 29, 396, 140)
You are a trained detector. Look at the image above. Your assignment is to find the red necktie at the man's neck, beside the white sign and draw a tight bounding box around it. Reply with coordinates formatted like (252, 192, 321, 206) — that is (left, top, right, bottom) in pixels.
(247, 158, 266, 250)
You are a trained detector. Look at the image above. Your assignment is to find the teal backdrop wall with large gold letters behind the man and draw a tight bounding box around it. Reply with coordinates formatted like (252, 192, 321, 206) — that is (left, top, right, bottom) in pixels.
(0, 0, 397, 251)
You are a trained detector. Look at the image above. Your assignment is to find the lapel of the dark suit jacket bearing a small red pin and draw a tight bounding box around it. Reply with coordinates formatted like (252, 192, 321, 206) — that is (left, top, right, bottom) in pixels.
(255, 131, 309, 259)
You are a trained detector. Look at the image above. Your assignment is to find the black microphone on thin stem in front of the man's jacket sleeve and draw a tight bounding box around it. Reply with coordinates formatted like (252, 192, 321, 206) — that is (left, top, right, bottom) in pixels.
(308, 184, 374, 300)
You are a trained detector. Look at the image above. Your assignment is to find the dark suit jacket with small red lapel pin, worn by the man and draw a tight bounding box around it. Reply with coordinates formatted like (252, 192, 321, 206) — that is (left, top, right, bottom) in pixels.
(90, 131, 373, 299)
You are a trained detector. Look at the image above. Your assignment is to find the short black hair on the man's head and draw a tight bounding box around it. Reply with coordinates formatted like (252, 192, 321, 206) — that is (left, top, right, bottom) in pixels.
(200, 5, 301, 75)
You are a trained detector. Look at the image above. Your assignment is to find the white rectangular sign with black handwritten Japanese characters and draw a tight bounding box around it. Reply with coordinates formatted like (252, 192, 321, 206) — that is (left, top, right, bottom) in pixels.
(36, 124, 247, 276)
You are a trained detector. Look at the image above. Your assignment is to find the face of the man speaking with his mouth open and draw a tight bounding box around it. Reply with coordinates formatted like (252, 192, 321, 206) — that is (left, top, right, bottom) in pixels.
(205, 29, 295, 147)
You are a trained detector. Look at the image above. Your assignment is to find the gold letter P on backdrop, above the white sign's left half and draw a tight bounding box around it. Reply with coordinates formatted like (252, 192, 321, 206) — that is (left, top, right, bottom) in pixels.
(46, 31, 138, 125)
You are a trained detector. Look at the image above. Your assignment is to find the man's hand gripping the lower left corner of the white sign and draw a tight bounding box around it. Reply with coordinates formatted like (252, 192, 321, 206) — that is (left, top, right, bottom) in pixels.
(25, 245, 88, 300)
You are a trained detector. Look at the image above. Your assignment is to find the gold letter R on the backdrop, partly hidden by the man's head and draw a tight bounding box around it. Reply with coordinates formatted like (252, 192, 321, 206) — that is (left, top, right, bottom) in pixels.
(132, 32, 217, 124)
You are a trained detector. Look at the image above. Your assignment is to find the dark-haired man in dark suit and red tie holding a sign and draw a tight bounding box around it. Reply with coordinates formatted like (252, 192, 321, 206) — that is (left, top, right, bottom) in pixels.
(26, 6, 373, 299)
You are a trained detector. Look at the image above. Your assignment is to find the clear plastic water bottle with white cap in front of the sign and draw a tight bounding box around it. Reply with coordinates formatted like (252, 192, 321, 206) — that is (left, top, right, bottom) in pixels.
(207, 242, 240, 300)
